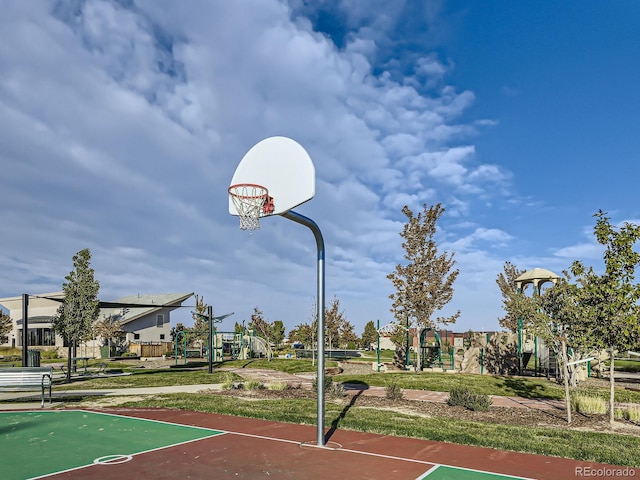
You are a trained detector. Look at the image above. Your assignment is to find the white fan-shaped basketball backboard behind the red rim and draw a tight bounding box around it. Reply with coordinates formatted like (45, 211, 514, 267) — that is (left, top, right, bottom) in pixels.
(229, 137, 316, 215)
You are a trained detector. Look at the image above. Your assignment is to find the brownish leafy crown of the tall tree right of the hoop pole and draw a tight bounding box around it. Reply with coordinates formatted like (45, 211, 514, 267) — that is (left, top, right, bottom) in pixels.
(387, 203, 460, 328)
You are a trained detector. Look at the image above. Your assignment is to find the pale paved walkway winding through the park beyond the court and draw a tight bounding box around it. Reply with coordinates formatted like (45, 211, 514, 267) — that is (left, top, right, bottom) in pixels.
(0, 368, 564, 410)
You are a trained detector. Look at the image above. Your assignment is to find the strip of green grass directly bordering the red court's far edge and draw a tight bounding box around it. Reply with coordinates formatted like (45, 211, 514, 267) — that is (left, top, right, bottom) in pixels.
(117, 394, 640, 467)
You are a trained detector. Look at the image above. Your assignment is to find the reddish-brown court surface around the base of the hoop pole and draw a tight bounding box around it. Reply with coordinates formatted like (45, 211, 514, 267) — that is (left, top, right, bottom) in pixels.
(28, 409, 640, 480)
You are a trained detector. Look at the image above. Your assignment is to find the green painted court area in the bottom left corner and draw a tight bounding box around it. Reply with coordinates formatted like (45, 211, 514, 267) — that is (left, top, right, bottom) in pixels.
(0, 410, 223, 480)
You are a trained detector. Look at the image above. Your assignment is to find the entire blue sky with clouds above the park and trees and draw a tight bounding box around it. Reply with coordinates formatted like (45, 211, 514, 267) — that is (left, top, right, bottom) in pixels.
(0, 0, 640, 333)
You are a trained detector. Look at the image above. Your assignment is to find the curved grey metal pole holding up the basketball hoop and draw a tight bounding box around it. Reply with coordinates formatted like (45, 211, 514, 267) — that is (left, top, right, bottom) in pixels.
(281, 210, 325, 446)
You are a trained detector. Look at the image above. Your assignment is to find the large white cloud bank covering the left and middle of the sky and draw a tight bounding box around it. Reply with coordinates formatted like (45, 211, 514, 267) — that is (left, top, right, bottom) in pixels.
(0, 0, 536, 338)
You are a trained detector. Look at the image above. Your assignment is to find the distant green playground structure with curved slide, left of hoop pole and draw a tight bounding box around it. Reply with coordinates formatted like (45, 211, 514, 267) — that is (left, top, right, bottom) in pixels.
(174, 330, 273, 365)
